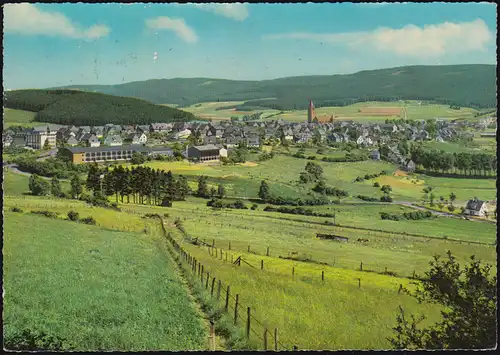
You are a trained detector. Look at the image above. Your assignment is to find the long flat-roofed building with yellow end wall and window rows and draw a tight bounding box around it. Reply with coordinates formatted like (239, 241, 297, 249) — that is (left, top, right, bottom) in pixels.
(60, 145, 173, 164)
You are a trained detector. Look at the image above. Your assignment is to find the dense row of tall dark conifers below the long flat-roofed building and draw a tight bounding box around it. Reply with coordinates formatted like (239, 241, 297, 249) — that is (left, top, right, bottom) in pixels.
(86, 164, 191, 205)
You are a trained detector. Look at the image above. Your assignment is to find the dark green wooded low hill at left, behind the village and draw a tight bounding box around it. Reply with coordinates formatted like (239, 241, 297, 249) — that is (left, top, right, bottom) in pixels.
(4, 90, 196, 126)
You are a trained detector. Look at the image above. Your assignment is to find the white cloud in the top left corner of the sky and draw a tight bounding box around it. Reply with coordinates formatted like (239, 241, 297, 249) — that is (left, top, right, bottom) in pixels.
(4, 3, 110, 39)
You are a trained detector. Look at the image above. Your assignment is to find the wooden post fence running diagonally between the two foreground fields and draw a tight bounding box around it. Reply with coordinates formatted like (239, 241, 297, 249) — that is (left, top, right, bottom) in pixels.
(158, 215, 290, 351)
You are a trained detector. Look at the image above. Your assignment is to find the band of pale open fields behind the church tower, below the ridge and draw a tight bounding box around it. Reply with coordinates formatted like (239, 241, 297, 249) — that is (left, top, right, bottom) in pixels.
(182, 100, 478, 122)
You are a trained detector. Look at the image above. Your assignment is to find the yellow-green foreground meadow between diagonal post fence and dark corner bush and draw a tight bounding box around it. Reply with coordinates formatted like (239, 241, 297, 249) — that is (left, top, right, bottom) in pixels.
(165, 224, 439, 350)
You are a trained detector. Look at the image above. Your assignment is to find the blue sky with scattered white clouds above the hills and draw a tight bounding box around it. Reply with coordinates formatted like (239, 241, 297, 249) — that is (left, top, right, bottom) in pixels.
(3, 3, 496, 89)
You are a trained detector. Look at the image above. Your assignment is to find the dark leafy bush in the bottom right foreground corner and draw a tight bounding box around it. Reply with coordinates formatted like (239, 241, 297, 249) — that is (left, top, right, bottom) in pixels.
(388, 251, 497, 349)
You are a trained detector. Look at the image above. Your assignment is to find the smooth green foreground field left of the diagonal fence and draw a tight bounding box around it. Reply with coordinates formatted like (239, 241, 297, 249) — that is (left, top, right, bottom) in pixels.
(3, 213, 208, 351)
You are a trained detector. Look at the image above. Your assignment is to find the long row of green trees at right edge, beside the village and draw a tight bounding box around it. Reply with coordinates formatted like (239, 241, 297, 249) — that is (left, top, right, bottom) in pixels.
(410, 145, 497, 176)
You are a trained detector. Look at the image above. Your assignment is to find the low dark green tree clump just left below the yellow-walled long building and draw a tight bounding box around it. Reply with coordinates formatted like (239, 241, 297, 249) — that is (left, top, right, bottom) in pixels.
(14, 156, 88, 179)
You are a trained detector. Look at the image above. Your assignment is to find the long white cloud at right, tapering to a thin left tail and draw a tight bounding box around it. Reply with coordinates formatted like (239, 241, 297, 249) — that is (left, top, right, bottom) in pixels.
(264, 19, 495, 58)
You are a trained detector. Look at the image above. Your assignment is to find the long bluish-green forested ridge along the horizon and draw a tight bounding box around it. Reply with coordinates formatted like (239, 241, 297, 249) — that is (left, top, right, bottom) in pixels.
(50, 64, 496, 110)
